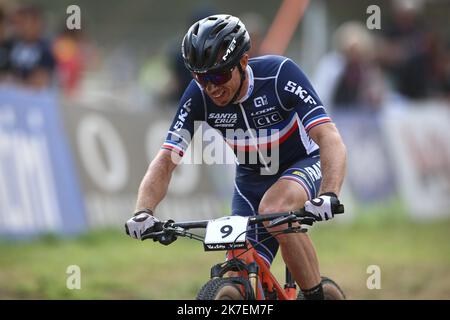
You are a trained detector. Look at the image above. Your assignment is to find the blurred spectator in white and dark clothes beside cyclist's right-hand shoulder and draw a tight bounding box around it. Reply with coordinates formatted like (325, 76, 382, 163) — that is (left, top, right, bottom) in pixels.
(313, 21, 384, 111)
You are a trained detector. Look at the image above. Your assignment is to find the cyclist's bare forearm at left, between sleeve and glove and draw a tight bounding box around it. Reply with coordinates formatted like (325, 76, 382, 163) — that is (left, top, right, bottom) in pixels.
(135, 149, 177, 212)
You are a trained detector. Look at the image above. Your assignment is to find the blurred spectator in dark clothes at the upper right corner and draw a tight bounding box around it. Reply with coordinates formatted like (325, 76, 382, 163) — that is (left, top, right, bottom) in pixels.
(379, 0, 437, 99)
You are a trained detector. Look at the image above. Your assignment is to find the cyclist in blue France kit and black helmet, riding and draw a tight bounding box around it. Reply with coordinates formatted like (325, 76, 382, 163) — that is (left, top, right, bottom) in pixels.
(126, 15, 346, 299)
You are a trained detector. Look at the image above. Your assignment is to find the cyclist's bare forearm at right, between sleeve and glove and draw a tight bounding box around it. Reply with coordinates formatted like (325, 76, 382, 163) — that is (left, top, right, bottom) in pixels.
(309, 123, 347, 196)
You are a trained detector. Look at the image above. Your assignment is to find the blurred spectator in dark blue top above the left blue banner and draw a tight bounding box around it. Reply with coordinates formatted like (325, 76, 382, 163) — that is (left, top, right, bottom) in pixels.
(10, 6, 55, 89)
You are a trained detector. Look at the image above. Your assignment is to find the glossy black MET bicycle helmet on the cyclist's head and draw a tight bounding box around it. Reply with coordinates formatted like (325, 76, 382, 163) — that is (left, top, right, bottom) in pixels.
(181, 14, 251, 73)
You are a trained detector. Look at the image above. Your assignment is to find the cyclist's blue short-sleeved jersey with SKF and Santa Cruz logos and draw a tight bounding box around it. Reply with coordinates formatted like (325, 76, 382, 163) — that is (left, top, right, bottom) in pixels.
(162, 55, 331, 170)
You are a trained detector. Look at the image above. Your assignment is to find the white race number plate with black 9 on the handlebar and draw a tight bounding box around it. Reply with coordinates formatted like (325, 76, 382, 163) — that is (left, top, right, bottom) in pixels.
(203, 216, 248, 251)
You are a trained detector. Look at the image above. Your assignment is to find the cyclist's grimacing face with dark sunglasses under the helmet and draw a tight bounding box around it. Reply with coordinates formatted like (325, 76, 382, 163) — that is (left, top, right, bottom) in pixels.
(195, 55, 248, 107)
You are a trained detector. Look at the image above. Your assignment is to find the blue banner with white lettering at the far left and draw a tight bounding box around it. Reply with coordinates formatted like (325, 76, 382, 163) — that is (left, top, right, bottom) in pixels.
(0, 86, 86, 237)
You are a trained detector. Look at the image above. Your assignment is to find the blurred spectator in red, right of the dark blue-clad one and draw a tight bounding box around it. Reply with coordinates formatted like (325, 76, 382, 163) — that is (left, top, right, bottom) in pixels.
(53, 24, 86, 96)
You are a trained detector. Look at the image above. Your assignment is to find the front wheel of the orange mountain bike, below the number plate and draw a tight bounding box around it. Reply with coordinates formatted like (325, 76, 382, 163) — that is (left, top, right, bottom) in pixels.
(197, 278, 247, 300)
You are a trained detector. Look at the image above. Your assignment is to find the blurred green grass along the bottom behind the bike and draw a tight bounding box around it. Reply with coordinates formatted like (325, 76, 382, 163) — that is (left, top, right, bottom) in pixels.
(0, 210, 450, 299)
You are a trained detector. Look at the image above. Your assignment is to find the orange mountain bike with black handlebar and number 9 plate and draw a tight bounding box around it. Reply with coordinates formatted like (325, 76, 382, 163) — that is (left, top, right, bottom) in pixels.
(142, 205, 345, 300)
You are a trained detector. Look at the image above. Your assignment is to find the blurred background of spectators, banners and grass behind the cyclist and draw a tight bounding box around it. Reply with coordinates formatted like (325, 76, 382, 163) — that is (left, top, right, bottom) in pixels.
(0, 0, 450, 299)
